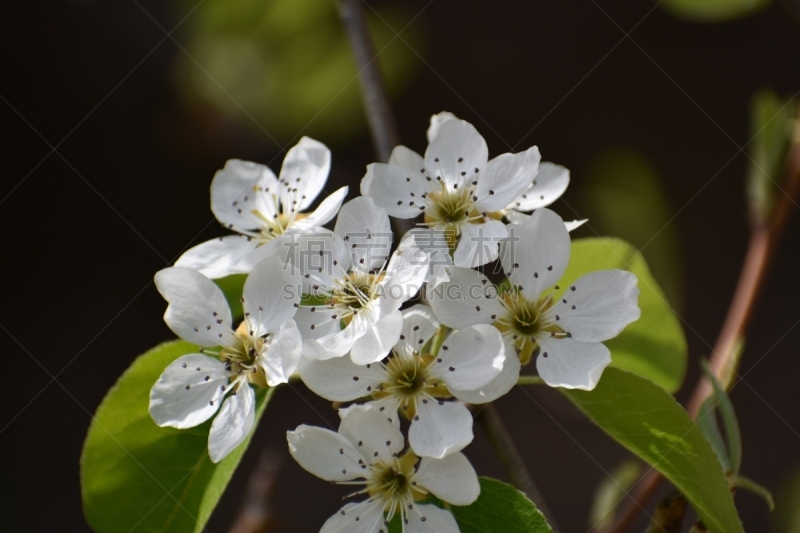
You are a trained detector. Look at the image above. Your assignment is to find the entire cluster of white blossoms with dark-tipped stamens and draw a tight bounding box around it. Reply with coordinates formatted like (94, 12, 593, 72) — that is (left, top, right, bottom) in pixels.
(150, 113, 639, 533)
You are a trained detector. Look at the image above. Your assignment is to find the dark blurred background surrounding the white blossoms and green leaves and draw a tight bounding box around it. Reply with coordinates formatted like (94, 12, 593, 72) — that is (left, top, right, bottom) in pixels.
(0, 0, 800, 533)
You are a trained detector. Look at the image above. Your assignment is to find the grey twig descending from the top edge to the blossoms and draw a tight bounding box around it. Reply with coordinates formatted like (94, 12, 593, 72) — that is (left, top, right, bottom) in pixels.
(340, 0, 400, 163)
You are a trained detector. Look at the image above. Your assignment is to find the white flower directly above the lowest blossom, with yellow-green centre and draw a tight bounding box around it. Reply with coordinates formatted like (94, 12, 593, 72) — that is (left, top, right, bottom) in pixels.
(300, 305, 504, 458)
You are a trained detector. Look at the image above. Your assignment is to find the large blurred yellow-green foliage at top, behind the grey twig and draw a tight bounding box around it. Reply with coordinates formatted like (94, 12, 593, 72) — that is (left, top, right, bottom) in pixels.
(175, 0, 426, 142)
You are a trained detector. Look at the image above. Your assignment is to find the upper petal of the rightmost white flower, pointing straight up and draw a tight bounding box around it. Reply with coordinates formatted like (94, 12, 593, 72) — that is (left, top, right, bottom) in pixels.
(500, 207, 570, 300)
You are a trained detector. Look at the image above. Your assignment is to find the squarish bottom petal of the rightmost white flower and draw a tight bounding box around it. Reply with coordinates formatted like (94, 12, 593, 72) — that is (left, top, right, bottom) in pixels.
(536, 336, 611, 390)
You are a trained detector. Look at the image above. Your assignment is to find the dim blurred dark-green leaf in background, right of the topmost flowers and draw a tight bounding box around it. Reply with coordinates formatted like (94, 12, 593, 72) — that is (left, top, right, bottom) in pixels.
(581, 148, 684, 309)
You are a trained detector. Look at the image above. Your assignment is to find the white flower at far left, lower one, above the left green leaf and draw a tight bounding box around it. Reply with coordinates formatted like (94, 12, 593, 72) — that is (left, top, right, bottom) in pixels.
(150, 257, 302, 463)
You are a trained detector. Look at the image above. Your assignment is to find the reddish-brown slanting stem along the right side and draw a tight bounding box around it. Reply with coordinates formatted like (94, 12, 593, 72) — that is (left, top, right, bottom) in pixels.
(608, 106, 800, 533)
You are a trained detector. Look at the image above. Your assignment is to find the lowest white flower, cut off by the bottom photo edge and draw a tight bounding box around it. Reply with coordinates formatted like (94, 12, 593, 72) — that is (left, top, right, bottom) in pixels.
(287, 406, 480, 533)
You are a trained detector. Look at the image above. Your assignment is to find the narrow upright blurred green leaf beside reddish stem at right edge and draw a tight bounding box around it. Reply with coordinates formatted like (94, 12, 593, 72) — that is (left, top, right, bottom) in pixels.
(747, 89, 797, 224)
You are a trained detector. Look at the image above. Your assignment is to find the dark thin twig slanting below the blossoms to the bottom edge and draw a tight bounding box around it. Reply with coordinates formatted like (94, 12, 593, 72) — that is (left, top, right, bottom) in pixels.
(476, 403, 558, 532)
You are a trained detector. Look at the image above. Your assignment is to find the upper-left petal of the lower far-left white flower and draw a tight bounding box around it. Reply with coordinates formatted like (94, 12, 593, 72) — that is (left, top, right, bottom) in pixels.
(155, 267, 233, 346)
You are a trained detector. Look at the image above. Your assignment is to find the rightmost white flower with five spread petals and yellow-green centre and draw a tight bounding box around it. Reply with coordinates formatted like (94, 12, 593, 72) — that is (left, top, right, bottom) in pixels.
(428, 208, 640, 395)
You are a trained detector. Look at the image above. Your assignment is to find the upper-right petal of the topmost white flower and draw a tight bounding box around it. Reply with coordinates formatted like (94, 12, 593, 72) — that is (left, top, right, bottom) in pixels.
(475, 146, 542, 212)
